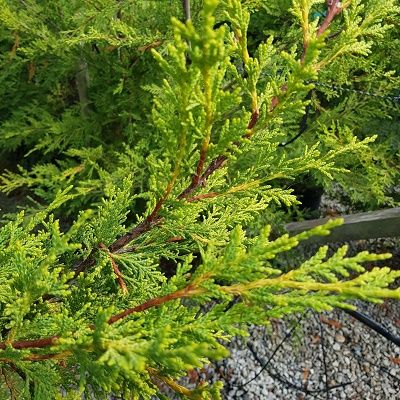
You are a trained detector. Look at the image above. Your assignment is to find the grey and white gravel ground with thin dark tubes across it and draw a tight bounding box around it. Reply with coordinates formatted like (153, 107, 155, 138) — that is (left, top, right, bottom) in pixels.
(211, 302, 400, 400)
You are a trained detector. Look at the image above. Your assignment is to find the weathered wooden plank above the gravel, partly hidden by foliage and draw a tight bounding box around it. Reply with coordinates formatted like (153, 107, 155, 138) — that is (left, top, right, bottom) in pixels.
(286, 207, 400, 243)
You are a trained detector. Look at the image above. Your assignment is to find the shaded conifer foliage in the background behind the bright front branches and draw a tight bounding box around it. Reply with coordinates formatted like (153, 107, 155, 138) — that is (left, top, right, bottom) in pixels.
(0, 1, 400, 216)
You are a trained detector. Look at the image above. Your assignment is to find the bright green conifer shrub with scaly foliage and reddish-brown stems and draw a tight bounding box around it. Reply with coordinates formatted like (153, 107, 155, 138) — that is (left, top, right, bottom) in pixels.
(0, 0, 400, 400)
